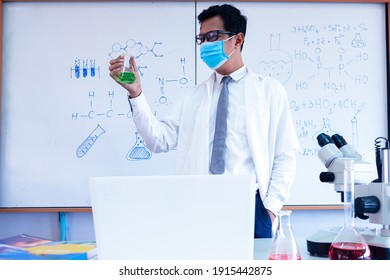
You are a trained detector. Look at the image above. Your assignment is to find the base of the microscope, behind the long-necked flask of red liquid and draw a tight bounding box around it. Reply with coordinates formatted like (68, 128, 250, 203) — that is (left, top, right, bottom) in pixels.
(306, 228, 390, 260)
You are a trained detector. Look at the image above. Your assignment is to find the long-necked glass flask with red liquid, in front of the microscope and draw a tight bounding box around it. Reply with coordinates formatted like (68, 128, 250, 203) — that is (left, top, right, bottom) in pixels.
(329, 159, 371, 260)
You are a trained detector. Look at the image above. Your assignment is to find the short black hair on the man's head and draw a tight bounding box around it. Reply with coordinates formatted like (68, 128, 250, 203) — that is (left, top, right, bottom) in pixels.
(198, 4, 247, 36)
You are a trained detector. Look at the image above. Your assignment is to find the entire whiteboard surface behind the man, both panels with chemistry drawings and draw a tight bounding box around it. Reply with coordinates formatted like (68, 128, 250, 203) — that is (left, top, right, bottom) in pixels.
(0, 2, 388, 207)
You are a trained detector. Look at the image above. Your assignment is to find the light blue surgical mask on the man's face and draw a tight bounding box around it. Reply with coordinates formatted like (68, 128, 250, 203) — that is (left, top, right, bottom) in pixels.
(200, 36, 236, 70)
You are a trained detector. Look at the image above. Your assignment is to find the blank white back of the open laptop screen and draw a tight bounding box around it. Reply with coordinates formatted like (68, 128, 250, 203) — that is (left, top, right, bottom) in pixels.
(90, 175, 255, 260)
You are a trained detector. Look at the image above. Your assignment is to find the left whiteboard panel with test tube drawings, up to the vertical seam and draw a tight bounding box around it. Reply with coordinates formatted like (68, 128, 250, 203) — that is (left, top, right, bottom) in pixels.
(0, 2, 195, 207)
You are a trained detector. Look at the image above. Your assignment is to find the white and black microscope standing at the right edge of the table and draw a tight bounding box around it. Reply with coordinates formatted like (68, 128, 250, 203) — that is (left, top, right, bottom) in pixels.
(306, 133, 390, 260)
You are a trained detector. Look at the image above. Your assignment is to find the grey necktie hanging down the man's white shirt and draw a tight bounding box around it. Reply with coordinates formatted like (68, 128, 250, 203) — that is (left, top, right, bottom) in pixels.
(210, 76, 232, 174)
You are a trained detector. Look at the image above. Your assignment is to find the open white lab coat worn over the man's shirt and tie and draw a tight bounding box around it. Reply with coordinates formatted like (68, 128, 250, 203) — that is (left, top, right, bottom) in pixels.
(130, 68, 299, 213)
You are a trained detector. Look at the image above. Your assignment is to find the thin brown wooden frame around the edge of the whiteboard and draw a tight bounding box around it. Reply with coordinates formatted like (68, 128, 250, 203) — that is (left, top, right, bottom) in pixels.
(0, 0, 390, 213)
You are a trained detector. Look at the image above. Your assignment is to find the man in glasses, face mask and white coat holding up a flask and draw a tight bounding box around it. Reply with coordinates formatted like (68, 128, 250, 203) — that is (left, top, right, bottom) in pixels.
(109, 4, 299, 238)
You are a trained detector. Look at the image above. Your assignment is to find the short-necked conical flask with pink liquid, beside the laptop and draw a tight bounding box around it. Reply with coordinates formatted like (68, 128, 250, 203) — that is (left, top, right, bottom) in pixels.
(269, 210, 301, 260)
